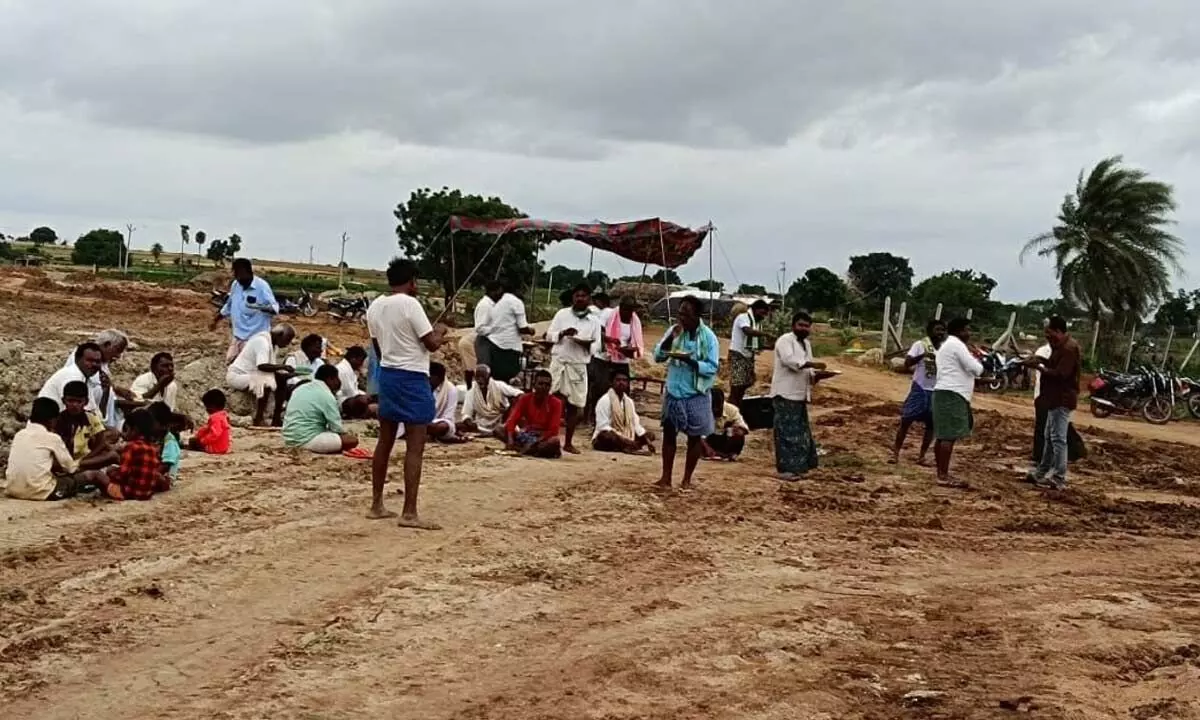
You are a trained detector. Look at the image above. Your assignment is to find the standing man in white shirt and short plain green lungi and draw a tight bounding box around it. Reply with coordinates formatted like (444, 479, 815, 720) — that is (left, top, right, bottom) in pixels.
(931, 318, 983, 487)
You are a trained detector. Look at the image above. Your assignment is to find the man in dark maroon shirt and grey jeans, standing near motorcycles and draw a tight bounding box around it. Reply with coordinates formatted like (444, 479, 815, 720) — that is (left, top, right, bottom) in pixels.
(1027, 316, 1082, 490)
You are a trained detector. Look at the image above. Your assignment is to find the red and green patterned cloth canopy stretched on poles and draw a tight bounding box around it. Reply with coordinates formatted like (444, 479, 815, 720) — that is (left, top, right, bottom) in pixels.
(450, 215, 712, 268)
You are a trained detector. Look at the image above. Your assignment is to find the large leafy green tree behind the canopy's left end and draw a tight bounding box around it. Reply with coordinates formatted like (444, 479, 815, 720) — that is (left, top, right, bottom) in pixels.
(394, 187, 535, 298)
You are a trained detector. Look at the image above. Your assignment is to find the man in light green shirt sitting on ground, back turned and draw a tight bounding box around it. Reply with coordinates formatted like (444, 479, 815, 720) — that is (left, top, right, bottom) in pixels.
(283, 365, 359, 455)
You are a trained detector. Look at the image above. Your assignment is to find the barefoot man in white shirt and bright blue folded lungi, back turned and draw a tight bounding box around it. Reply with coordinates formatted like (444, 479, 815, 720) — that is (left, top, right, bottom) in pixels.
(366, 258, 445, 530)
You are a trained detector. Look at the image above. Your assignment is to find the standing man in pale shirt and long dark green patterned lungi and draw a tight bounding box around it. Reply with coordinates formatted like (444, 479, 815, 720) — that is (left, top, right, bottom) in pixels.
(770, 310, 826, 482)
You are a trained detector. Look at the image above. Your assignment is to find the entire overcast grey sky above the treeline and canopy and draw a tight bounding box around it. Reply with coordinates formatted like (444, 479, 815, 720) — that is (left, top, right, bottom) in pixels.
(0, 0, 1200, 300)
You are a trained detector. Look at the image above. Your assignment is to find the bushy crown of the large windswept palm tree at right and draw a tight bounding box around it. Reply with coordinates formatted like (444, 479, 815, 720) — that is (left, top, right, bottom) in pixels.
(1021, 155, 1183, 323)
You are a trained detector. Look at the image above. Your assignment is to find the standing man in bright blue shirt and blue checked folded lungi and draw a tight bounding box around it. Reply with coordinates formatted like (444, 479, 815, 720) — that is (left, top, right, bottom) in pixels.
(654, 295, 721, 490)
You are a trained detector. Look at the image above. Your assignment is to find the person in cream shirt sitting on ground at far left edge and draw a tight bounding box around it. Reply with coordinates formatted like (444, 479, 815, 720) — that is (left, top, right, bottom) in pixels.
(5, 397, 113, 500)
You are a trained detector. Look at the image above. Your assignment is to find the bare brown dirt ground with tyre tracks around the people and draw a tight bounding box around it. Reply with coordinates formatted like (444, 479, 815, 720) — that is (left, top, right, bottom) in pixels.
(0, 276, 1200, 720)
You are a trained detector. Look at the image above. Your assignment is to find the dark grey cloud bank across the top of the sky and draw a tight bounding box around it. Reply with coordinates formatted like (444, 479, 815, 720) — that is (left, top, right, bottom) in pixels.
(0, 0, 1196, 156)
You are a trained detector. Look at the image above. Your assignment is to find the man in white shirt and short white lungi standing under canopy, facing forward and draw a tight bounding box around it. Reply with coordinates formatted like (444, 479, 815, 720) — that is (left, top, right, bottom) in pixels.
(546, 284, 600, 455)
